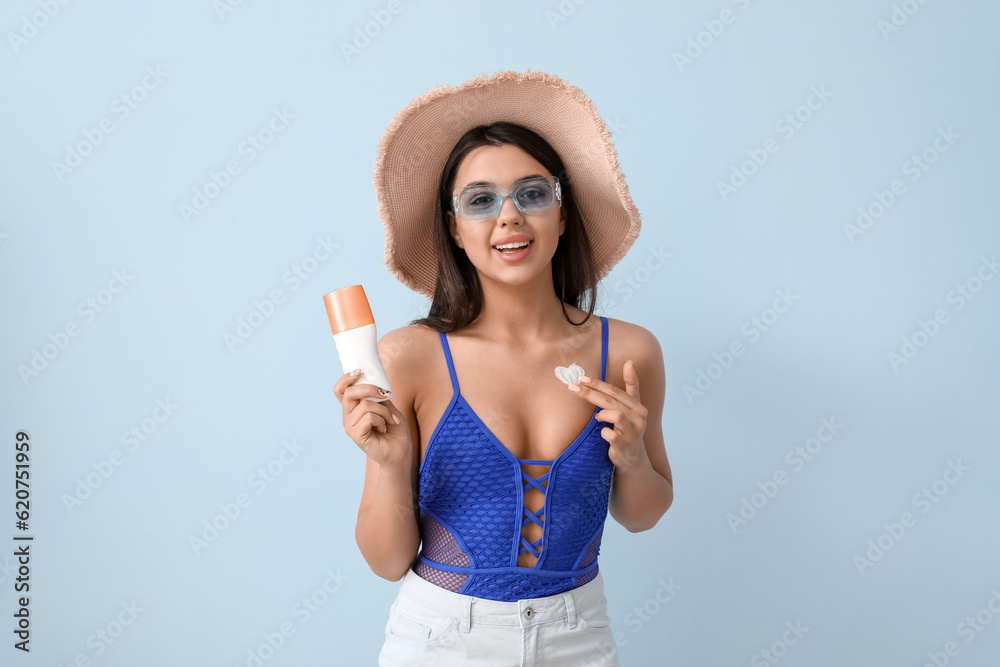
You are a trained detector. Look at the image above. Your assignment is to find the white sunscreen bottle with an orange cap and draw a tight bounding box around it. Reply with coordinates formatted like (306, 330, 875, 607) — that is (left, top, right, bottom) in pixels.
(323, 285, 392, 401)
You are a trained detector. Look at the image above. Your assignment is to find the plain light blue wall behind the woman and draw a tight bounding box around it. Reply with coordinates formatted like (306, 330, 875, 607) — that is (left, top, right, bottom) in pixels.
(0, 0, 1000, 667)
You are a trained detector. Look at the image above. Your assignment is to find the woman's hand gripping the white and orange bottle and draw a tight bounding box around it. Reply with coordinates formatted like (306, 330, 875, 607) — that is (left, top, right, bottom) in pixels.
(333, 373, 413, 468)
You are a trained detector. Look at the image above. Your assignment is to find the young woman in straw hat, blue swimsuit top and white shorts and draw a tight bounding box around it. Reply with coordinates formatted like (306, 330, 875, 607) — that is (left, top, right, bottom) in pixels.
(334, 70, 673, 667)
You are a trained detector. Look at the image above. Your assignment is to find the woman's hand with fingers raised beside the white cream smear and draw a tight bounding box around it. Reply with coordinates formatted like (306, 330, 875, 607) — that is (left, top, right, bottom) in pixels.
(567, 360, 649, 471)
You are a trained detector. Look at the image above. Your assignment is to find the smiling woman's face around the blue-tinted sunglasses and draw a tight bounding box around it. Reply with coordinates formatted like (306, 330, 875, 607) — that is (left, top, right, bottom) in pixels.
(447, 144, 566, 284)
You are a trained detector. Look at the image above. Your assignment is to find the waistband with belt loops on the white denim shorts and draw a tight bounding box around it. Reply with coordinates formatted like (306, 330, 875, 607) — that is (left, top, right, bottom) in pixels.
(399, 569, 605, 632)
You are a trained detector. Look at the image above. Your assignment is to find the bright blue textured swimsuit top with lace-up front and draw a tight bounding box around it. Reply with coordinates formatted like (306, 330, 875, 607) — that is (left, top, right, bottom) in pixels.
(414, 317, 614, 602)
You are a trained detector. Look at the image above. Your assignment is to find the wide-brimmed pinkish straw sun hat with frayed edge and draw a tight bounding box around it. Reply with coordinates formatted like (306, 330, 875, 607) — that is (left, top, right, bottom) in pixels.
(374, 69, 640, 297)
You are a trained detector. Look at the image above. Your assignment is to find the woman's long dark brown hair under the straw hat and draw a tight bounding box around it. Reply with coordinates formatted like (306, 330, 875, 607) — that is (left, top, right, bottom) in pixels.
(410, 122, 597, 333)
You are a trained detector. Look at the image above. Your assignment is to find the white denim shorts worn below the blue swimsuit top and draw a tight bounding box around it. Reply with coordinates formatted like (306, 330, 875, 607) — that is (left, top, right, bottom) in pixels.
(378, 569, 620, 667)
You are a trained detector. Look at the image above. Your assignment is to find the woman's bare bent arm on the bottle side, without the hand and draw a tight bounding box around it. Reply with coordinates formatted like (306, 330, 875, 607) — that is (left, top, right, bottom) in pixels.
(354, 327, 420, 581)
